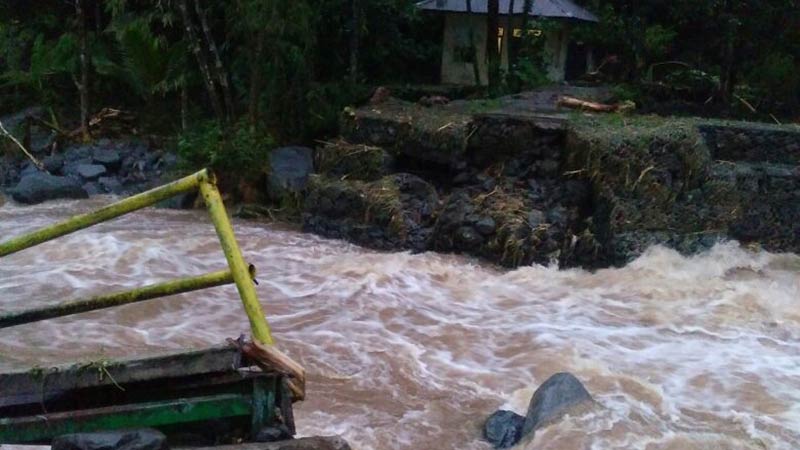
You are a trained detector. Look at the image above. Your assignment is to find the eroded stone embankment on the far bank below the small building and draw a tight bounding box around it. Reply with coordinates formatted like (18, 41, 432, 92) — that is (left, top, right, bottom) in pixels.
(303, 95, 800, 267)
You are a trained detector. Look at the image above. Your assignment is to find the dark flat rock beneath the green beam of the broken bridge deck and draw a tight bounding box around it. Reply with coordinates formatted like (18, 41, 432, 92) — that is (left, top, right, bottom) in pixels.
(52, 429, 169, 450)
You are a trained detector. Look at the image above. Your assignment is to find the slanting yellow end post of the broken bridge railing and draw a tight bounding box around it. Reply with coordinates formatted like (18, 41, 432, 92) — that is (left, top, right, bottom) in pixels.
(200, 177, 274, 345)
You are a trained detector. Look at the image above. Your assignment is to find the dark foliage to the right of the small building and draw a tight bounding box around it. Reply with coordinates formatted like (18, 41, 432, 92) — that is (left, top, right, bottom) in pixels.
(583, 0, 800, 119)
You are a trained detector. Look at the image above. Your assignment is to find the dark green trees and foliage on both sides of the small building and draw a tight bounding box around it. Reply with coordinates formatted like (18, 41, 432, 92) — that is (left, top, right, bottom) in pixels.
(0, 0, 800, 171)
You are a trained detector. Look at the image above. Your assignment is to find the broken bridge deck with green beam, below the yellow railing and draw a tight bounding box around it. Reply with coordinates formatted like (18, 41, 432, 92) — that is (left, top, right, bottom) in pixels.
(0, 347, 286, 444)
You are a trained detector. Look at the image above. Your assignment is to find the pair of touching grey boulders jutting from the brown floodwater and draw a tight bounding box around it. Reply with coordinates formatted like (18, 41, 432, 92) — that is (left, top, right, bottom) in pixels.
(483, 373, 594, 449)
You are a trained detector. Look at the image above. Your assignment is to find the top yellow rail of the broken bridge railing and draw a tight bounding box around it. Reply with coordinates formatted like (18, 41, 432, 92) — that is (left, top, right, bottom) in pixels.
(0, 170, 209, 258)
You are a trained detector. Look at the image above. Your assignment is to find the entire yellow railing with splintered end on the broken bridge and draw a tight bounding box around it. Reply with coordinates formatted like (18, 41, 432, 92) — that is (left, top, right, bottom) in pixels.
(0, 170, 305, 399)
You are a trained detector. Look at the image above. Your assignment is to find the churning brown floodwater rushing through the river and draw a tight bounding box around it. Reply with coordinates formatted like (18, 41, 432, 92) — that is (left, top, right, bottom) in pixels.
(0, 198, 800, 450)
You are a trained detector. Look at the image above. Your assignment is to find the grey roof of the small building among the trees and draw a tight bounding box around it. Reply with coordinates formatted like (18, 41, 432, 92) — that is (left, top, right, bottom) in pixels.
(417, 0, 597, 22)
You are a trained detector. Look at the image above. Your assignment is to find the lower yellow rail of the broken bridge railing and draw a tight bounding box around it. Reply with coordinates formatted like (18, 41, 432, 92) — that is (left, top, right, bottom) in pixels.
(0, 265, 255, 328)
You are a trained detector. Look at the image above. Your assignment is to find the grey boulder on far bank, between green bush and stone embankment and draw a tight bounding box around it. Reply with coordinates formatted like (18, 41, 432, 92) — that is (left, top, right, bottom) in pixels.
(268, 147, 314, 199)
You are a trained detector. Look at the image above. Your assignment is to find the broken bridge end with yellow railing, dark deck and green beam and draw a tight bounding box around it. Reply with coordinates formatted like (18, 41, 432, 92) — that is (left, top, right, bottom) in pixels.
(0, 170, 298, 444)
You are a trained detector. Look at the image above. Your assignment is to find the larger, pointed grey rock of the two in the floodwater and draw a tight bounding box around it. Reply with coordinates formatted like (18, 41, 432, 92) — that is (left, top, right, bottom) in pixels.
(522, 372, 594, 436)
